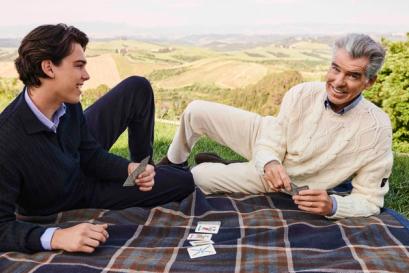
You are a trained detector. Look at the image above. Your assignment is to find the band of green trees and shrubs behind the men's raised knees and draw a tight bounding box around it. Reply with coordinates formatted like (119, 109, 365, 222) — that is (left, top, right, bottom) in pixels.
(151, 71, 303, 119)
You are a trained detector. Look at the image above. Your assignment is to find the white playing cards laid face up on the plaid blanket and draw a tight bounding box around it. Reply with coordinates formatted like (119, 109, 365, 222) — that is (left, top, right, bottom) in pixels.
(187, 221, 221, 259)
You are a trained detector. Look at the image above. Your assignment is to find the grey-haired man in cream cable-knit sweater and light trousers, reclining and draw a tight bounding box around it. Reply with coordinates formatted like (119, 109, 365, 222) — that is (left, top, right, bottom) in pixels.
(161, 34, 393, 218)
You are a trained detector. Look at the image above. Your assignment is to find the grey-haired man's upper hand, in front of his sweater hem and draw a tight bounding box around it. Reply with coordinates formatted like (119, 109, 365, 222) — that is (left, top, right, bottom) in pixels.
(264, 160, 291, 191)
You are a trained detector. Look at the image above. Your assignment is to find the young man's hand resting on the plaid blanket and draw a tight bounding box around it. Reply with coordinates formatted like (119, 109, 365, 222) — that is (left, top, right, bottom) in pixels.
(51, 223, 109, 253)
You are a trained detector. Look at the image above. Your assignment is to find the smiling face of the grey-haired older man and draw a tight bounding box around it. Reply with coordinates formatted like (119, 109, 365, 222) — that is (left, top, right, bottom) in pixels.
(326, 49, 375, 111)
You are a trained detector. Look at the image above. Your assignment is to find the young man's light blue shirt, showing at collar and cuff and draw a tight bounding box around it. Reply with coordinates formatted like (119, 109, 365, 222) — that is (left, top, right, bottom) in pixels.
(24, 88, 66, 250)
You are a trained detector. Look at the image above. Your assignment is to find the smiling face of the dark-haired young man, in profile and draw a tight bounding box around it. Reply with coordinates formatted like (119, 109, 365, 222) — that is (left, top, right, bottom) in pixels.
(52, 43, 89, 103)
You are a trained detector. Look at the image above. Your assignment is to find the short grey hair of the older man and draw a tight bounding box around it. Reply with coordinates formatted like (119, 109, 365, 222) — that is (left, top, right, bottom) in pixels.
(333, 33, 385, 80)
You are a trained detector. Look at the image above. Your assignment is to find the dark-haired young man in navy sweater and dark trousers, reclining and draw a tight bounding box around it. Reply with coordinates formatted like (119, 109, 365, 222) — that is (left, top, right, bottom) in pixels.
(0, 24, 194, 252)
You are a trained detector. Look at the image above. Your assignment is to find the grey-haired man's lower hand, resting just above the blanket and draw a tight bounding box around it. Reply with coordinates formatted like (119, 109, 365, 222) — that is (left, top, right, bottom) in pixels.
(293, 190, 332, 216)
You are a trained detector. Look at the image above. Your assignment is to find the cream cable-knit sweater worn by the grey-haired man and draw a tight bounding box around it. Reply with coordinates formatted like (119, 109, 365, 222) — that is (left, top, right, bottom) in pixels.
(253, 82, 393, 218)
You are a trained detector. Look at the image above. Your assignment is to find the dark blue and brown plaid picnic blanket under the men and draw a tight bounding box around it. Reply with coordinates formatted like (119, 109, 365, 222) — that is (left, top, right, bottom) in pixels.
(0, 190, 409, 273)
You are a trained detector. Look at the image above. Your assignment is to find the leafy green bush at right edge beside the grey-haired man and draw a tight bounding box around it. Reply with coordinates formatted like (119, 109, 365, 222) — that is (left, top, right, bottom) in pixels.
(365, 33, 409, 153)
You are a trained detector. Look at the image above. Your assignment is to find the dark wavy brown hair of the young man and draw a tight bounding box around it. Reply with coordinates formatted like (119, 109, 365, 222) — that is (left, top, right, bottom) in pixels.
(14, 24, 88, 87)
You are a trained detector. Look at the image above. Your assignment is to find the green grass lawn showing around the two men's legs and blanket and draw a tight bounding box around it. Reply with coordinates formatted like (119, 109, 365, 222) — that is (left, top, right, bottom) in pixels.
(111, 123, 409, 218)
